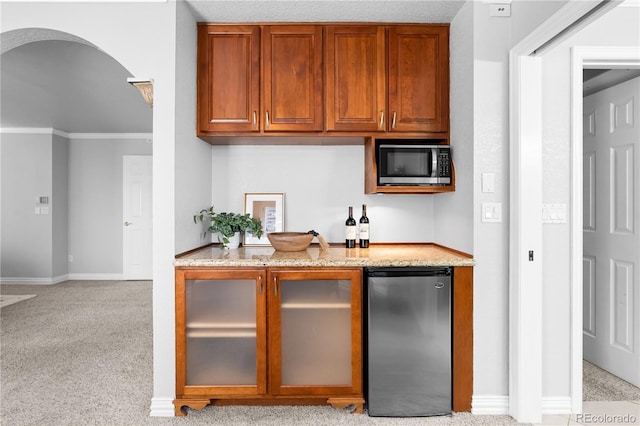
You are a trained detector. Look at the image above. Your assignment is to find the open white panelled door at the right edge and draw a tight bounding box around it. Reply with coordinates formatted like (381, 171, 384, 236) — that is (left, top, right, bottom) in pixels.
(583, 78, 640, 386)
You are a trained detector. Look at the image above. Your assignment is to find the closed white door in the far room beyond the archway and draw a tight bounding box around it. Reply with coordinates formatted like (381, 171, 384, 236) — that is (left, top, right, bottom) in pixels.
(122, 155, 153, 280)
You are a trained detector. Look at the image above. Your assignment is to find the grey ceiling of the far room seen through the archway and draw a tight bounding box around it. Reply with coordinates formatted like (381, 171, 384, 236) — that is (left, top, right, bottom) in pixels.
(0, 40, 152, 133)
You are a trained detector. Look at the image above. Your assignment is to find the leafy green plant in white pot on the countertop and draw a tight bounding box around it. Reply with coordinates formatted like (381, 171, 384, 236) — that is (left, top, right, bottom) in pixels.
(193, 206, 262, 248)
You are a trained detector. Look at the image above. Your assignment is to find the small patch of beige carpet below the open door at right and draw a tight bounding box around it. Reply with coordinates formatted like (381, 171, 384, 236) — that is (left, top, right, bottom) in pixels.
(582, 361, 640, 401)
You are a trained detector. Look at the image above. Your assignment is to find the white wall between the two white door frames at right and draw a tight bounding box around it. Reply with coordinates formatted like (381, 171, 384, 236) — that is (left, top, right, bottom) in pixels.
(542, 6, 640, 396)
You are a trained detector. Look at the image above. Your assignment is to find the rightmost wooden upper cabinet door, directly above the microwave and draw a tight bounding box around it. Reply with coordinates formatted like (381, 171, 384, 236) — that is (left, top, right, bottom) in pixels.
(388, 25, 449, 132)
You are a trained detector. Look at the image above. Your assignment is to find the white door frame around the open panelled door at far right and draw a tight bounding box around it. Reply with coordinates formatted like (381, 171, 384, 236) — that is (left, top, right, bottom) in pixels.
(570, 46, 640, 413)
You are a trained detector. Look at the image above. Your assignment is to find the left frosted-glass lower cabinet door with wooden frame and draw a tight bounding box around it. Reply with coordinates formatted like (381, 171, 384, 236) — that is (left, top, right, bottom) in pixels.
(176, 270, 266, 394)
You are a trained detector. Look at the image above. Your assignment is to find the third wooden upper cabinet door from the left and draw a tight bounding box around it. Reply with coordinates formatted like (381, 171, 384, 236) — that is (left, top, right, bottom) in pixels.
(325, 26, 387, 132)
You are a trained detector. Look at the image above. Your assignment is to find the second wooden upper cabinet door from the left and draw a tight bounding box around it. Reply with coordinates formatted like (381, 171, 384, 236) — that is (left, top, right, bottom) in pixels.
(261, 25, 323, 132)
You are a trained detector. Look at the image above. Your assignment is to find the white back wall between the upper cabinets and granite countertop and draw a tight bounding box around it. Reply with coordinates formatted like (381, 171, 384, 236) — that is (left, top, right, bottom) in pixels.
(210, 139, 434, 243)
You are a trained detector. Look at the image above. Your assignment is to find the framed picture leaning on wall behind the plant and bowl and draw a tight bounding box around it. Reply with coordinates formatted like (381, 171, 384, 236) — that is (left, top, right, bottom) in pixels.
(242, 192, 284, 247)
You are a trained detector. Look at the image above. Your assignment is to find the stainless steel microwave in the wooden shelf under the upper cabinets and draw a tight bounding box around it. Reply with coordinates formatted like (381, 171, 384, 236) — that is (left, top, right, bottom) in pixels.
(376, 143, 451, 186)
